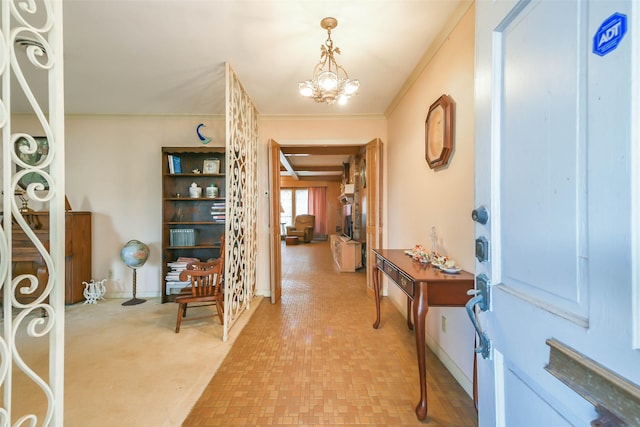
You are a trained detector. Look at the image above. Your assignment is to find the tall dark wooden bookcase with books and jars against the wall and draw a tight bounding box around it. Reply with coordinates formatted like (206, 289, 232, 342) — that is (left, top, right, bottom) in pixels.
(161, 147, 226, 302)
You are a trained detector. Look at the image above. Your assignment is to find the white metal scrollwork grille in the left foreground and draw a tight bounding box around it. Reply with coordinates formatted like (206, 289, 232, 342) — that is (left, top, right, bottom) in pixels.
(0, 0, 65, 426)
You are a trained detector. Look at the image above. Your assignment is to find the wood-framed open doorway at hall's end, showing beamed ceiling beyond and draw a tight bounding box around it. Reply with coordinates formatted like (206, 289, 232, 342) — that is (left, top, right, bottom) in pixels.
(269, 139, 382, 303)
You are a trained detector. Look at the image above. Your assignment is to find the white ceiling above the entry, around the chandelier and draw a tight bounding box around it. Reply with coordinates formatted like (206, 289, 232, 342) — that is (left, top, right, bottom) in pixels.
(8, 0, 470, 115)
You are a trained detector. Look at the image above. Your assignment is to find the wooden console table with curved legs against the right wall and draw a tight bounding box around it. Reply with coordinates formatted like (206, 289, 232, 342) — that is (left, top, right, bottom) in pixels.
(372, 249, 474, 421)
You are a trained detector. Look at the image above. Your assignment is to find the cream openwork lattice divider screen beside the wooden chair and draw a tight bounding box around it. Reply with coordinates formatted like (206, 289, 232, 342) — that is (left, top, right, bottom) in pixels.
(223, 64, 258, 340)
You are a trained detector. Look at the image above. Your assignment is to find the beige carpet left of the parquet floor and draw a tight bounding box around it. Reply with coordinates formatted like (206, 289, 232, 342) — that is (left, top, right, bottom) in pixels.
(12, 297, 268, 427)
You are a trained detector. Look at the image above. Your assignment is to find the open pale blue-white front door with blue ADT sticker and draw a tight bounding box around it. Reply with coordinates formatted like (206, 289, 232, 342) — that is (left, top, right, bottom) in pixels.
(475, 0, 640, 427)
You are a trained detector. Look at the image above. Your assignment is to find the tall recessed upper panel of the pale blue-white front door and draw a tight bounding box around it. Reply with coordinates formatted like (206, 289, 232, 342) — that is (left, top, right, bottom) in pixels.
(494, 2, 588, 324)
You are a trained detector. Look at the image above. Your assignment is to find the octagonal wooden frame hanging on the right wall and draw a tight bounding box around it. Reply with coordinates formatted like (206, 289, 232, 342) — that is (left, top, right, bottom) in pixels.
(424, 95, 455, 169)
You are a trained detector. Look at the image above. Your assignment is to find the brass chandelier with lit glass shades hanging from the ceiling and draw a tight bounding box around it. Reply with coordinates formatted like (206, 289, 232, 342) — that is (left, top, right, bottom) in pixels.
(298, 18, 360, 104)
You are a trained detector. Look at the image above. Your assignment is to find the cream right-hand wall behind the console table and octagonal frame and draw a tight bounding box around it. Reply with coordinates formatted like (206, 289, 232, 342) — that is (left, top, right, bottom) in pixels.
(385, 7, 475, 393)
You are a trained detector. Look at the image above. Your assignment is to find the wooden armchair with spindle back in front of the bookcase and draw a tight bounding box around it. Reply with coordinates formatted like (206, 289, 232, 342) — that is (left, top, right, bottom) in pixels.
(176, 257, 224, 333)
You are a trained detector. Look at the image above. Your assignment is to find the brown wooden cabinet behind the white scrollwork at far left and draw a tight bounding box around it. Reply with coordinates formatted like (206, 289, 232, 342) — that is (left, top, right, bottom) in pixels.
(12, 211, 91, 304)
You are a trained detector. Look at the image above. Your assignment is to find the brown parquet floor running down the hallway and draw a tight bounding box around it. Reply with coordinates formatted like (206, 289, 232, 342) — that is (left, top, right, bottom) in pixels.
(183, 242, 477, 427)
